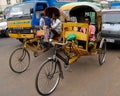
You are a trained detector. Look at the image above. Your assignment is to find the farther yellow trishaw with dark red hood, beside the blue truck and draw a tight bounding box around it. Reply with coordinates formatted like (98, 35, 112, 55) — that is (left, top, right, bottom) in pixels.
(9, 7, 67, 73)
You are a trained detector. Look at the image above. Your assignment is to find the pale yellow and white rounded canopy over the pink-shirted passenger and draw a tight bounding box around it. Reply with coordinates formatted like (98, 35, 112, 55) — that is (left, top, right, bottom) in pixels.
(60, 2, 102, 21)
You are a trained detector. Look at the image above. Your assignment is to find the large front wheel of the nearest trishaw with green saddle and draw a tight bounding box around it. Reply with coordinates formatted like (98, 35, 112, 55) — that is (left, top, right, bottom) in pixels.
(35, 59, 61, 96)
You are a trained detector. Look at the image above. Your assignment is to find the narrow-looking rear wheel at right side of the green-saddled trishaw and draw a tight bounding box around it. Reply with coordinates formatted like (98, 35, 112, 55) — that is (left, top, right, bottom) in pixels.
(99, 40, 106, 65)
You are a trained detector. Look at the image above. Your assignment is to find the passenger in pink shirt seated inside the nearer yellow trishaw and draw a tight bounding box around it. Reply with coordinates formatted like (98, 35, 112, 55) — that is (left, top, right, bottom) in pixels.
(80, 16, 96, 49)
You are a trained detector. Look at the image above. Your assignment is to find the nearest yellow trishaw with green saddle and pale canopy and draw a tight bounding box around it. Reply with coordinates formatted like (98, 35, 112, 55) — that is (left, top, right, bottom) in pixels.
(35, 2, 106, 96)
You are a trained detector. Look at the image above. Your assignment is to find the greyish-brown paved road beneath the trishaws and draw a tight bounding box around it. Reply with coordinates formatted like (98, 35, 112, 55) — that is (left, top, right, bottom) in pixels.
(0, 38, 120, 96)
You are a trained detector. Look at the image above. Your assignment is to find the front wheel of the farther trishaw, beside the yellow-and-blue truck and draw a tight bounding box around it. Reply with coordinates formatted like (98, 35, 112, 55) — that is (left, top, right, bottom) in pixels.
(9, 48, 30, 73)
